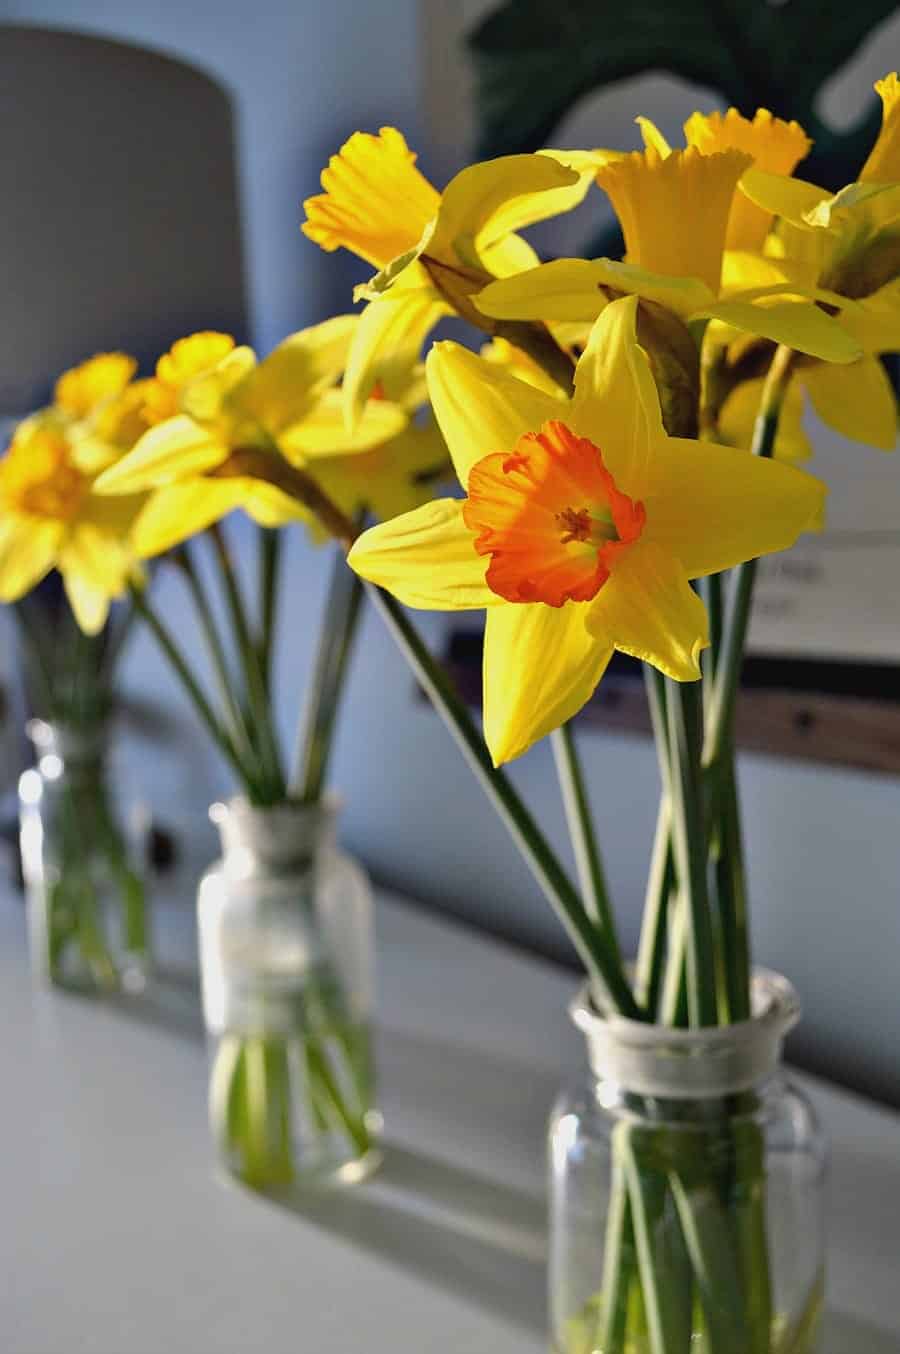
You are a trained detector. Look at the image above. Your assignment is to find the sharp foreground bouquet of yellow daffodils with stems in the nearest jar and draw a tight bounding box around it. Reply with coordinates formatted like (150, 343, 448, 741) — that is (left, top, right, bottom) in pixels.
(293, 90, 900, 1354)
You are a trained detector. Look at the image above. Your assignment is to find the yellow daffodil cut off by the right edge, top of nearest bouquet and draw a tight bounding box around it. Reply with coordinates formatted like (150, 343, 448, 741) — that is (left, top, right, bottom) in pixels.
(731, 74, 900, 451)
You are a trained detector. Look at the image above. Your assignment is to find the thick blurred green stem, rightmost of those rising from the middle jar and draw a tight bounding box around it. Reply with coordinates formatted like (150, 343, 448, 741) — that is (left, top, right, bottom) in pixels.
(290, 554, 364, 804)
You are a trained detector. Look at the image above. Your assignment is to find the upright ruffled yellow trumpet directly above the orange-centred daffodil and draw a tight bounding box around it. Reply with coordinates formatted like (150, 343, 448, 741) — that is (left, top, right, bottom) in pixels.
(597, 146, 750, 294)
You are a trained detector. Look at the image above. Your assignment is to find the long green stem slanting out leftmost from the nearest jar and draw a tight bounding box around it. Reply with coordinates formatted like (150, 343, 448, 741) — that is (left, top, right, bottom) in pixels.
(367, 584, 642, 1020)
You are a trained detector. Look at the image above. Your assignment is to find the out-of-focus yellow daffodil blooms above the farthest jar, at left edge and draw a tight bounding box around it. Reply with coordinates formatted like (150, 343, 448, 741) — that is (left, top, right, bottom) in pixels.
(0, 353, 146, 634)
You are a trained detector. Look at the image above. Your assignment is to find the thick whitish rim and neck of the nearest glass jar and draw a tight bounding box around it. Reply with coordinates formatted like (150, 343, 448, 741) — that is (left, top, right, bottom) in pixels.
(571, 969, 800, 1101)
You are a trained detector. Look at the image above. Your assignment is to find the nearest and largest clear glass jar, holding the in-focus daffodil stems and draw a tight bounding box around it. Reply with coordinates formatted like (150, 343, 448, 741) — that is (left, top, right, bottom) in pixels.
(549, 971, 824, 1354)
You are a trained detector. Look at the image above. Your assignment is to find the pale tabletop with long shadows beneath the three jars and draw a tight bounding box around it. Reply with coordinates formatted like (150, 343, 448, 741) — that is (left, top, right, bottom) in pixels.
(0, 894, 900, 1354)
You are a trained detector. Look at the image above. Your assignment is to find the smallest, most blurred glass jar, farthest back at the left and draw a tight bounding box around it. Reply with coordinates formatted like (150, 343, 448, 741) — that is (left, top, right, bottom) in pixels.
(19, 719, 150, 992)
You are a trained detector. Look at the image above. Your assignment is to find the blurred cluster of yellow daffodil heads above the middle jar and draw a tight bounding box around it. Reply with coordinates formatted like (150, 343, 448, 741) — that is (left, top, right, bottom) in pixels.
(100, 315, 441, 558)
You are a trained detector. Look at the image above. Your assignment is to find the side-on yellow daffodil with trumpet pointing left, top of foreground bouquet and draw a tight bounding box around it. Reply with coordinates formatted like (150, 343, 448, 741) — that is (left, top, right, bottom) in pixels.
(303, 127, 603, 421)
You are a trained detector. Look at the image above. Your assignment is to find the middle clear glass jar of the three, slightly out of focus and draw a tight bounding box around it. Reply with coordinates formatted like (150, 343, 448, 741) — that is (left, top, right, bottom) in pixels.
(198, 799, 382, 1192)
